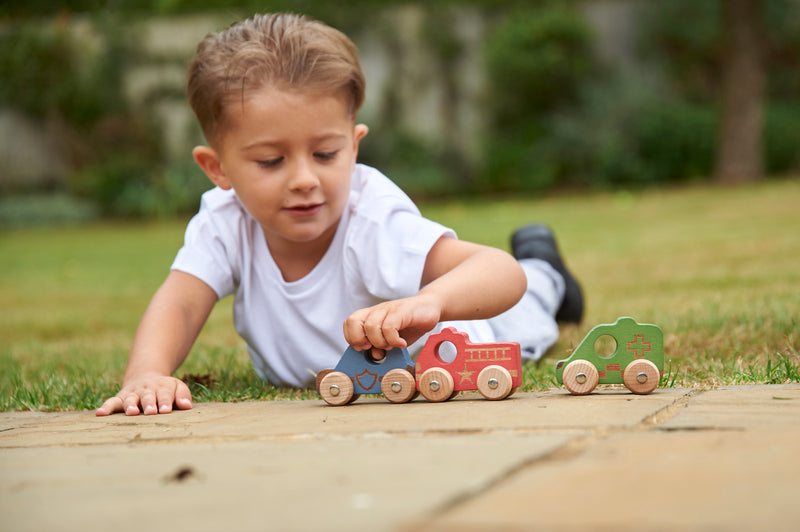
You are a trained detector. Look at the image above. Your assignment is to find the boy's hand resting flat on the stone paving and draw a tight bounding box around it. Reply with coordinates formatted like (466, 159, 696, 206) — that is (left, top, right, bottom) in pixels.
(95, 375, 192, 416)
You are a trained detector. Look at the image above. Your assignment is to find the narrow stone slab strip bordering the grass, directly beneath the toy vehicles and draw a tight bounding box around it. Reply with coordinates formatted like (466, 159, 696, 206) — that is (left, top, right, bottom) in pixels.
(0, 390, 689, 448)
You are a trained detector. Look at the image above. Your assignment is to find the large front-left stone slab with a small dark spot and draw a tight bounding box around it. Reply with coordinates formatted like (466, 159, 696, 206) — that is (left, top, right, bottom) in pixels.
(0, 433, 571, 531)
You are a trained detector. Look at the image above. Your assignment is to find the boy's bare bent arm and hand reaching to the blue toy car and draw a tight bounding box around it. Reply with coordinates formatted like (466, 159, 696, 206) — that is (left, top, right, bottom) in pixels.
(344, 237, 527, 349)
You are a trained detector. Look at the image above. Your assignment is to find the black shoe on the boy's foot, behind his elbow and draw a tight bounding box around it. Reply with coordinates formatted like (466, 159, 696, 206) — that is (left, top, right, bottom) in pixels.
(511, 224, 583, 324)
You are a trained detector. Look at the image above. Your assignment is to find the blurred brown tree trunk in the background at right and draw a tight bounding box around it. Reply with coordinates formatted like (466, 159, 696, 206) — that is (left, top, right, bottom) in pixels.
(715, 0, 766, 183)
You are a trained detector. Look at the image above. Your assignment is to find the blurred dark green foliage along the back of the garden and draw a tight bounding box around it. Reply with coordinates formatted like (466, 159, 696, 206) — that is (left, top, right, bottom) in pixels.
(0, 0, 800, 225)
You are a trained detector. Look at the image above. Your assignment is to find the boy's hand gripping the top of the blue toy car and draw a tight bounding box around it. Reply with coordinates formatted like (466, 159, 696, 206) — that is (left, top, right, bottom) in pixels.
(344, 293, 441, 358)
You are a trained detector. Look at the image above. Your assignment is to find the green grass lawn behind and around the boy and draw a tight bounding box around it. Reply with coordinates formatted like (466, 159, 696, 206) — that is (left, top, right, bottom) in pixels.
(0, 179, 800, 411)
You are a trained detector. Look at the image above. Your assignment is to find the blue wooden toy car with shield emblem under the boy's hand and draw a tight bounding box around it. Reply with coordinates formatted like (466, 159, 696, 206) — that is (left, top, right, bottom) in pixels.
(317, 347, 417, 406)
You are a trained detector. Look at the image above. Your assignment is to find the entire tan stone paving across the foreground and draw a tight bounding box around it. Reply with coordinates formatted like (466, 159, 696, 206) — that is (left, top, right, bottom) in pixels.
(0, 384, 800, 531)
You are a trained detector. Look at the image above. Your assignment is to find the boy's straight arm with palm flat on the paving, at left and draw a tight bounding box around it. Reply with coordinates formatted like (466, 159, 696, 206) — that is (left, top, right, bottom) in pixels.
(95, 270, 217, 416)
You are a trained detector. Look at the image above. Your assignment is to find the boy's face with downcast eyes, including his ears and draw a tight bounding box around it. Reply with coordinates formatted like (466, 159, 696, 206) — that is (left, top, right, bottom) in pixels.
(194, 88, 367, 260)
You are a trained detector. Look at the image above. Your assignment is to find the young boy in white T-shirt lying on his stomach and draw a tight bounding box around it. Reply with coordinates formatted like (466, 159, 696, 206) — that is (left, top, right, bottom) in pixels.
(96, 10, 582, 416)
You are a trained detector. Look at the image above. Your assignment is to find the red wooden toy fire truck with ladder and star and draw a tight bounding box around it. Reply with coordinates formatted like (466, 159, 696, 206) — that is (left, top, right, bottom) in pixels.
(416, 327, 522, 402)
